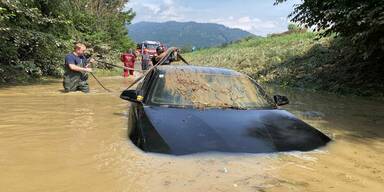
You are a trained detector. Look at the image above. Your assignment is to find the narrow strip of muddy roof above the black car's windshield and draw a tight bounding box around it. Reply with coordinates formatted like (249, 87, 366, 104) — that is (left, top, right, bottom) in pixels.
(157, 65, 243, 76)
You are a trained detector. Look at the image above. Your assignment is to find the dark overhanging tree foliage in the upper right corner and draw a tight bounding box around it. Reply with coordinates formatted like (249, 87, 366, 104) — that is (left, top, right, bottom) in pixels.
(276, 0, 384, 64)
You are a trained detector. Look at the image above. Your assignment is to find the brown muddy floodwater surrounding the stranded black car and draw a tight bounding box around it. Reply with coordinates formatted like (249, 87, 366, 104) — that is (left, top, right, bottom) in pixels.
(0, 77, 384, 192)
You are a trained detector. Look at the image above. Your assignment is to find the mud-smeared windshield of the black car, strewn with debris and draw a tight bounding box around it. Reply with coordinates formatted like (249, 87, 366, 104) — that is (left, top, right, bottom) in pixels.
(150, 72, 275, 109)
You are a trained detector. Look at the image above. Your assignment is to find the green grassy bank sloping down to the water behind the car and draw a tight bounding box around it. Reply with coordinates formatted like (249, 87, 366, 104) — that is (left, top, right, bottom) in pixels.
(185, 32, 384, 95)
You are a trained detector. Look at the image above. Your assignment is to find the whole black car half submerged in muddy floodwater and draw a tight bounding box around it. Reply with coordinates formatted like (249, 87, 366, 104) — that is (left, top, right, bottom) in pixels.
(120, 65, 330, 155)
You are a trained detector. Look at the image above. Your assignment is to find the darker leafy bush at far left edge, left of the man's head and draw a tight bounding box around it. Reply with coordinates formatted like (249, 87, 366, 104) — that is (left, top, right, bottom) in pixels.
(0, 0, 68, 82)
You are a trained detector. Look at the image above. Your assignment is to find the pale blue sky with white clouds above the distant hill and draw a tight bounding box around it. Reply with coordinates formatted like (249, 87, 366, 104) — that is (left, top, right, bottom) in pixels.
(126, 0, 301, 36)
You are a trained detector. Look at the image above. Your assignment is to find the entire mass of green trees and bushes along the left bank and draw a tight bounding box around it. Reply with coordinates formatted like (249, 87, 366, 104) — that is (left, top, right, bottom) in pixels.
(0, 0, 135, 83)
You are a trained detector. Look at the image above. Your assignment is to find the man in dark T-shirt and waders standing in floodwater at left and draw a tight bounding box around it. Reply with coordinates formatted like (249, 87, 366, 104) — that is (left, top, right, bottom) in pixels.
(63, 43, 92, 93)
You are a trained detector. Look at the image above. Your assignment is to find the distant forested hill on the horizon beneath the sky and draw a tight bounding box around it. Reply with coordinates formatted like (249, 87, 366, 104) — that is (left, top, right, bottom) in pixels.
(128, 21, 254, 48)
